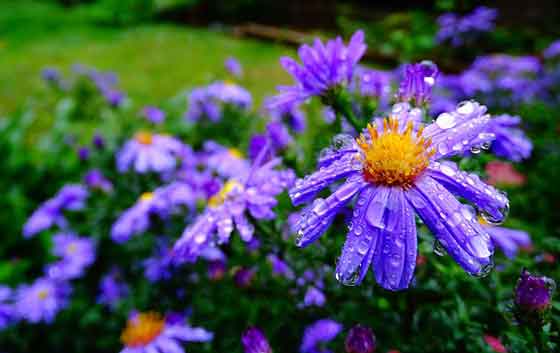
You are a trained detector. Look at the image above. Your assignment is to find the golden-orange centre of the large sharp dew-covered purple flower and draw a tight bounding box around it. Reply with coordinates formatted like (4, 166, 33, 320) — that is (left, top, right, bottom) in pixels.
(356, 118, 435, 188)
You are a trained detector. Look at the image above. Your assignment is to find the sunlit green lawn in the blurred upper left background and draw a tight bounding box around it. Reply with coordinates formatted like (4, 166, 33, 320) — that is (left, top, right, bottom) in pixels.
(0, 0, 291, 115)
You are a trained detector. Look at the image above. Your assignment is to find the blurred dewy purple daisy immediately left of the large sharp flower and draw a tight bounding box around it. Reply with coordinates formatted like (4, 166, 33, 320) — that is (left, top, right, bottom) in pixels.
(173, 148, 295, 262)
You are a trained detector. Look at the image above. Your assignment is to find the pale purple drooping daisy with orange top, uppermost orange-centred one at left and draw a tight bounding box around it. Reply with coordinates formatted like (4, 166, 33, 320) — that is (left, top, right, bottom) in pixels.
(116, 132, 187, 173)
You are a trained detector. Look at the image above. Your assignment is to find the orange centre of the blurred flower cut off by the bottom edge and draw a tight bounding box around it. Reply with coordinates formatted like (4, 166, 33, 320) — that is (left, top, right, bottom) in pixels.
(121, 312, 165, 348)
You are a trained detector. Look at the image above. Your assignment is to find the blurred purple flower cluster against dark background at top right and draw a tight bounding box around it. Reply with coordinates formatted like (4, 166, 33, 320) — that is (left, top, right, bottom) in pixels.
(436, 6, 498, 47)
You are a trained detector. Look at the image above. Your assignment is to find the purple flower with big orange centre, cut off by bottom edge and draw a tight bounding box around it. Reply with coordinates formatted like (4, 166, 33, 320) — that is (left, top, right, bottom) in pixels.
(121, 312, 213, 353)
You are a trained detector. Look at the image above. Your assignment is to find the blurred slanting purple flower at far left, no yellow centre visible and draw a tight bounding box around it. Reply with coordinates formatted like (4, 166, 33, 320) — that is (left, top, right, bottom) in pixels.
(23, 184, 89, 238)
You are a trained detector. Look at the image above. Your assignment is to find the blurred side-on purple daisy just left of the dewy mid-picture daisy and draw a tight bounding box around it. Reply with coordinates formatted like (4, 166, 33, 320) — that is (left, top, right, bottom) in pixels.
(111, 182, 196, 243)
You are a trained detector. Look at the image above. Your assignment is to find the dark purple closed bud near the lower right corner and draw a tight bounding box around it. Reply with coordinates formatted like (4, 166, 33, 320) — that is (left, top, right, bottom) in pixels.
(515, 269, 554, 311)
